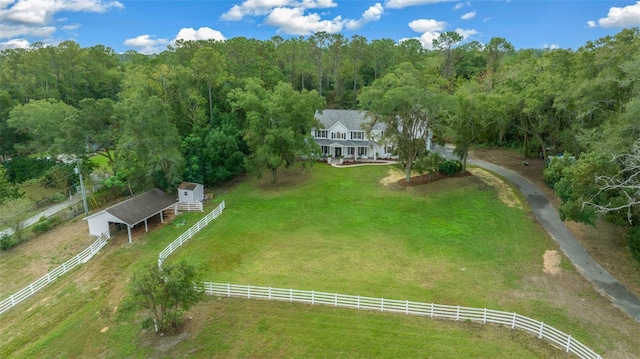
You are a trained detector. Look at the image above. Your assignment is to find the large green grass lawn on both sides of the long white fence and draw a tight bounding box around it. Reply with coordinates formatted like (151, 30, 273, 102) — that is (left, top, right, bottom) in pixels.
(0, 166, 626, 358)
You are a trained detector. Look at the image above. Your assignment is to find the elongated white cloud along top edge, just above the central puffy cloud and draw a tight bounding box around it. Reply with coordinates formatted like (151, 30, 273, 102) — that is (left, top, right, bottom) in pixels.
(220, 0, 338, 21)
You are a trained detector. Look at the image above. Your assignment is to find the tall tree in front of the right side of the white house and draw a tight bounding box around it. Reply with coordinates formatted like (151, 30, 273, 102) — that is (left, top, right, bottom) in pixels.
(358, 63, 443, 182)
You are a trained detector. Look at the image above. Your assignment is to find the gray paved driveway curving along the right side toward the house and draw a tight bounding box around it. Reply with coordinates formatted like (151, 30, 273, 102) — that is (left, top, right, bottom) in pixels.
(435, 146, 640, 322)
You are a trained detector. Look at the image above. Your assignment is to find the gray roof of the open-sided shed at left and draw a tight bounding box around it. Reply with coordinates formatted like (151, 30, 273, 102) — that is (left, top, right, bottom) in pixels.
(104, 188, 178, 226)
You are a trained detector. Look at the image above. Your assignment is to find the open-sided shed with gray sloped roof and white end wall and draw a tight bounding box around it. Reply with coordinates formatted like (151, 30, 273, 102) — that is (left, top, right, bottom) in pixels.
(84, 188, 178, 243)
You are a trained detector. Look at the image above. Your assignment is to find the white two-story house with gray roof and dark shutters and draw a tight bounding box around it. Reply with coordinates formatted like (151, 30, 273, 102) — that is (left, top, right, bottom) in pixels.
(312, 110, 392, 160)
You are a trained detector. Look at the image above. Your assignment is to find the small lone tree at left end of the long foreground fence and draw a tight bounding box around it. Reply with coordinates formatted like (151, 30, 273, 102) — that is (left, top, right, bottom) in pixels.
(128, 260, 204, 333)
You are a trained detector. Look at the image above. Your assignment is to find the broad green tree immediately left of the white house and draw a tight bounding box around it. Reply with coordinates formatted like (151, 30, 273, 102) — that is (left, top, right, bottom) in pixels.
(229, 78, 325, 182)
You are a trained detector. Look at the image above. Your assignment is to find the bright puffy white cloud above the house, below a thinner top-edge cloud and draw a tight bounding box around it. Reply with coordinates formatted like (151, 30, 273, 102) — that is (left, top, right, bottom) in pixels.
(265, 7, 346, 35)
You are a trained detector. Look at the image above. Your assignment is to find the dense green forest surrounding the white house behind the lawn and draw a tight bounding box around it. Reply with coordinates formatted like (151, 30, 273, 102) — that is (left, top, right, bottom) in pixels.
(0, 28, 640, 260)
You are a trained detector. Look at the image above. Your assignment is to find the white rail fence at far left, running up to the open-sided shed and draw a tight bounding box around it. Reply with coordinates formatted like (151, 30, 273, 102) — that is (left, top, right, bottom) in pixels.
(0, 235, 108, 314)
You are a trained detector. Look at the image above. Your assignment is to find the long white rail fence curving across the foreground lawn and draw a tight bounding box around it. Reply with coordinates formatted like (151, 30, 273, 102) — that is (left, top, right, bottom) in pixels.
(203, 282, 601, 359)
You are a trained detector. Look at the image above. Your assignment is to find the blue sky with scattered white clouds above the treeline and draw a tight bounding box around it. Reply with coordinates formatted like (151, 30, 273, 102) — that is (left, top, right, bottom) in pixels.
(0, 0, 640, 54)
